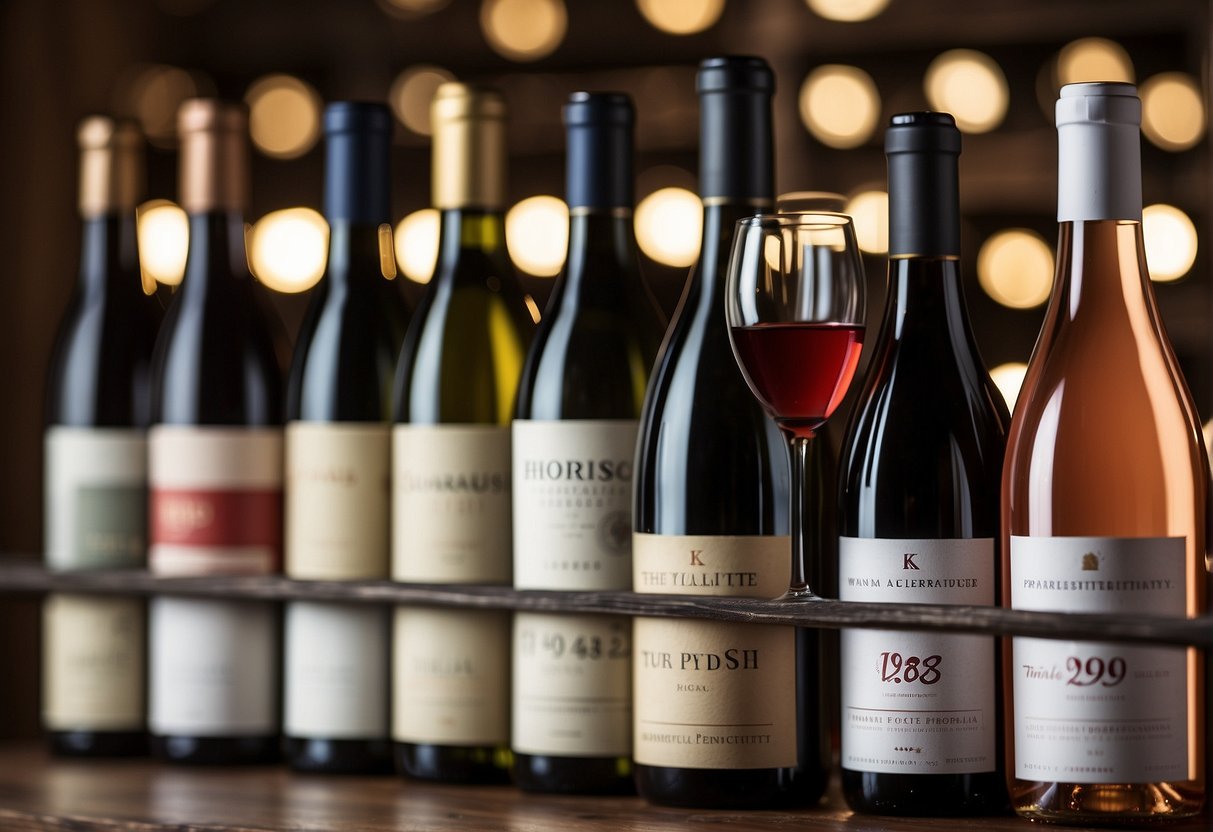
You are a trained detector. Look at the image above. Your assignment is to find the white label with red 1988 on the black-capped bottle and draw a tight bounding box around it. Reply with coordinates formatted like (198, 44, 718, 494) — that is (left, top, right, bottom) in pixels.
(838, 537, 998, 774)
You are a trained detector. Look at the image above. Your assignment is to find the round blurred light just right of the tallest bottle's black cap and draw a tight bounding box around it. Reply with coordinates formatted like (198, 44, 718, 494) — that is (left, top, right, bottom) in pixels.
(801, 64, 881, 148)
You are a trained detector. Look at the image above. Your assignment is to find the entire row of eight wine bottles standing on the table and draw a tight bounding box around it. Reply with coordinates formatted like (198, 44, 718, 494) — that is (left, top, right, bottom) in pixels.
(45, 58, 1208, 820)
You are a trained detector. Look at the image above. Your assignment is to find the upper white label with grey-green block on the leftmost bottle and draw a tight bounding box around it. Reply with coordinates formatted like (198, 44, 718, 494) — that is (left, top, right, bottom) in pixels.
(45, 426, 148, 570)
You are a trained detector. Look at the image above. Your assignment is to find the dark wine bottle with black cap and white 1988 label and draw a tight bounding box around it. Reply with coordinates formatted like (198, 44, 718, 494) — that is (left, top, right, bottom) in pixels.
(838, 113, 1009, 815)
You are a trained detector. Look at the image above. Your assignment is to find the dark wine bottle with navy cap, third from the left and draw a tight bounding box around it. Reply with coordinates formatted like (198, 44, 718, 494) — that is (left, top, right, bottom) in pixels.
(283, 102, 408, 773)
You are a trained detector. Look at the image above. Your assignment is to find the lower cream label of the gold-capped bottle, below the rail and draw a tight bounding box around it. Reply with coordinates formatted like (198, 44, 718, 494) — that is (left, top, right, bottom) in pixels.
(392, 606, 509, 746)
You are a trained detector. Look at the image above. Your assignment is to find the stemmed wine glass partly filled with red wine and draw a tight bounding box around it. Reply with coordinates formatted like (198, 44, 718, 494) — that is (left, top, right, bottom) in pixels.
(725, 211, 864, 599)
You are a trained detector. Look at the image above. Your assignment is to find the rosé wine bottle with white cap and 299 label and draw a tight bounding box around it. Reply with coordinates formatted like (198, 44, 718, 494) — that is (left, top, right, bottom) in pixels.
(1002, 84, 1209, 824)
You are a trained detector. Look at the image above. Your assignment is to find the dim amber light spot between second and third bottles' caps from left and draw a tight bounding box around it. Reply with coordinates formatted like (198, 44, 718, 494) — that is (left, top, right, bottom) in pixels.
(244, 75, 320, 159)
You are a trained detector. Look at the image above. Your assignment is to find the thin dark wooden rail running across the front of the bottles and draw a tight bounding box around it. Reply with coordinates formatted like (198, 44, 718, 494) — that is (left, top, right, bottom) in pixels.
(0, 557, 1213, 649)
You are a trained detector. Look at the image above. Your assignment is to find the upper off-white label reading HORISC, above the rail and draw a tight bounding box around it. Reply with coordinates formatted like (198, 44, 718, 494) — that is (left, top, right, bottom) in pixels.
(513, 420, 639, 589)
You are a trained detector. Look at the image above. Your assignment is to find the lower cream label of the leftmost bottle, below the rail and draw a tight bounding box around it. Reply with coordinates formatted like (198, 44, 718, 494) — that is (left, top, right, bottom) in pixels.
(42, 594, 144, 731)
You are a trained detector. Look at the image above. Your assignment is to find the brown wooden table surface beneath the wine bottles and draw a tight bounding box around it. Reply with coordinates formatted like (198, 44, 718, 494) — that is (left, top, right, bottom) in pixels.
(0, 742, 1213, 832)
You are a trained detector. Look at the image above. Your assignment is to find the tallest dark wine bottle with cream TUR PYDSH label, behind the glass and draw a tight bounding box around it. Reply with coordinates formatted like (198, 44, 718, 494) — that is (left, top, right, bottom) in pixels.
(632, 57, 827, 808)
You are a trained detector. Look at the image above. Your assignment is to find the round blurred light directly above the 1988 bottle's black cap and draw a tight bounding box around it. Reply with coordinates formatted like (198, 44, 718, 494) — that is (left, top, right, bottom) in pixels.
(923, 49, 1009, 133)
